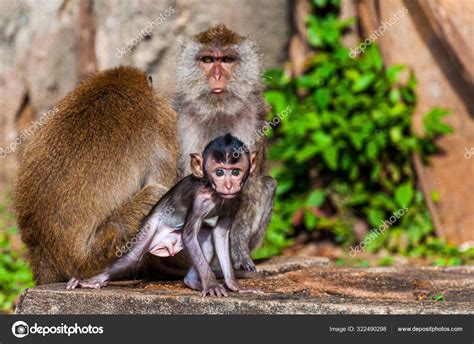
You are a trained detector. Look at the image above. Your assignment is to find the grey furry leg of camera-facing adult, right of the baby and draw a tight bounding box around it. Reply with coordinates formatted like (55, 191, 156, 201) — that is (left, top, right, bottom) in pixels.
(230, 176, 276, 272)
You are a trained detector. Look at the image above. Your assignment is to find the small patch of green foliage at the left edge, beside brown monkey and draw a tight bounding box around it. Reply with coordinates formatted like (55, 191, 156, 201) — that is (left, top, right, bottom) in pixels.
(0, 192, 33, 313)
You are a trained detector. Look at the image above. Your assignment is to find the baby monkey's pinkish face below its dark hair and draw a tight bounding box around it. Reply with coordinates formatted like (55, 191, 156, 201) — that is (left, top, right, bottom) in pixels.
(205, 155, 250, 199)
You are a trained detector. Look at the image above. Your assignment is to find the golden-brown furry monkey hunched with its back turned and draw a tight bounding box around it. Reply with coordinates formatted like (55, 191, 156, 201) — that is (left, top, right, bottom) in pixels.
(14, 67, 178, 283)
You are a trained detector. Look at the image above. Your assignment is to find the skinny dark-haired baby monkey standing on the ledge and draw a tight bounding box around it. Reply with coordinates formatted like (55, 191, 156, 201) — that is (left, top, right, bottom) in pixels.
(66, 134, 258, 297)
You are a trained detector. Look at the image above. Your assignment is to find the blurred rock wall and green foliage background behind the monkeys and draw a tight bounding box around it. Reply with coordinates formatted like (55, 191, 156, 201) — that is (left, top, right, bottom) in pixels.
(0, 0, 474, 312)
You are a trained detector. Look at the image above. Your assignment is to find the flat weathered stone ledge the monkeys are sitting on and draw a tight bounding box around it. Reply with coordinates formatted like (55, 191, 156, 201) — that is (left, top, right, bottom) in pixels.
(16, 257, 474, 314)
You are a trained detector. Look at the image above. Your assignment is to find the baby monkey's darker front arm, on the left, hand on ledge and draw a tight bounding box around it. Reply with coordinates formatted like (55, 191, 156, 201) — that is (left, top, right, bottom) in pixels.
(183, 195, 228, 297)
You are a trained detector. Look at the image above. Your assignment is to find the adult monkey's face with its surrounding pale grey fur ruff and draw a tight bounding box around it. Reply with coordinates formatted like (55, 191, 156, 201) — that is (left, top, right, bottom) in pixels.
(176, 34, 262, 118)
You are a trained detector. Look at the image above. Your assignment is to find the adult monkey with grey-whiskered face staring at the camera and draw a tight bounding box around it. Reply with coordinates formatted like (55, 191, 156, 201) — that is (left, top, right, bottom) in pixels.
(174, 24, 276, 271)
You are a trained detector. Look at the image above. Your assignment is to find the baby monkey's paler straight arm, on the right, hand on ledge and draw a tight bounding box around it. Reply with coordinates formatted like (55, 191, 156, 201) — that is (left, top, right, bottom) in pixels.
(212, 217, 260, 293)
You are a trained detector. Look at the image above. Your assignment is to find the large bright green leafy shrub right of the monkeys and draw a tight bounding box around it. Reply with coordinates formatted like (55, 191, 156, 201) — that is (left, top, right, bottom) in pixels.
(255, 0, 468, 264)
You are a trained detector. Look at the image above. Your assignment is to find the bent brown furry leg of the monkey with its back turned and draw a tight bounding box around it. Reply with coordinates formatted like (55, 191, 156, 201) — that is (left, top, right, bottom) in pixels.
(81, 184, 168, 276)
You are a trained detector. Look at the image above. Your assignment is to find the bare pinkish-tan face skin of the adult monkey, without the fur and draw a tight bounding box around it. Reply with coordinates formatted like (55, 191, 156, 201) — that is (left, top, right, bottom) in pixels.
(197, 49, 239, 96)
